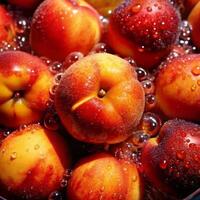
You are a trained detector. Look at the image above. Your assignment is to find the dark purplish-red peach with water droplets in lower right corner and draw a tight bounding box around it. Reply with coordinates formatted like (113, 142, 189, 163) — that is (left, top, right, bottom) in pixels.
(141, 120, 200, 197)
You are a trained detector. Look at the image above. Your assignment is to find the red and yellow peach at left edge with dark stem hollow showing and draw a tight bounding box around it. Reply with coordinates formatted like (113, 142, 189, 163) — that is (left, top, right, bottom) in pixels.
(0, 51, 53, 128)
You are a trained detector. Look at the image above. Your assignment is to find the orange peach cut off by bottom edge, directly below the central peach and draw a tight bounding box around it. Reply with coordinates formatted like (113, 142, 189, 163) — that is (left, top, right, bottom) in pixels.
(67, 153, 142, 200)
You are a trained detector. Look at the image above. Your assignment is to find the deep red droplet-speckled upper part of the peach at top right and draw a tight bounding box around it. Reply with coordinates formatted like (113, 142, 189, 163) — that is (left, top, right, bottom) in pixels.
(111, 0, 180, 50)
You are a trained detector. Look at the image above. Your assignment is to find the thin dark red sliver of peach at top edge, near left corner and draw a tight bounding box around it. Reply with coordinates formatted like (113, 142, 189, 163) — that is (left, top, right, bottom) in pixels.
(8, 0, 43, 9)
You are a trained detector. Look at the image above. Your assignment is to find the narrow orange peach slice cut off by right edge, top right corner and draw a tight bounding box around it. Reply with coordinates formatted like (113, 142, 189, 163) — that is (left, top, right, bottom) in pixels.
(188, 2, 200, 48)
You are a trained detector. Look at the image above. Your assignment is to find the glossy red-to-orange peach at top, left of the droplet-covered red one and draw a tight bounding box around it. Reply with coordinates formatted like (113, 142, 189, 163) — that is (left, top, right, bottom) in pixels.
(30, 0, 101, 60)
